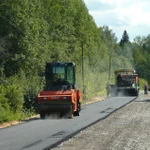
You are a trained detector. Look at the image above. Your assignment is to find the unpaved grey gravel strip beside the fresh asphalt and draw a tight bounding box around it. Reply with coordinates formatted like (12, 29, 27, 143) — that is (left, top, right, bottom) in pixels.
(53, 93, 150, 150)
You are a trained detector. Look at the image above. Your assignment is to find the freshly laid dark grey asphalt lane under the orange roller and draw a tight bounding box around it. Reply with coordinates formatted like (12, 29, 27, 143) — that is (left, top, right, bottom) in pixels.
(0, 97, 136, 150)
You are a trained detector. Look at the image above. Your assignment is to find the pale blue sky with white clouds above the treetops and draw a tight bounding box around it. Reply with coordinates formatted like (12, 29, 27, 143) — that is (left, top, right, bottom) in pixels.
(83, 0, 150, 41)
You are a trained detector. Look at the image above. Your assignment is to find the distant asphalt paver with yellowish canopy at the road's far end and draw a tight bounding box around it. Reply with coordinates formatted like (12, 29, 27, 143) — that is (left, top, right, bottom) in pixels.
(111, 69, 139, 96)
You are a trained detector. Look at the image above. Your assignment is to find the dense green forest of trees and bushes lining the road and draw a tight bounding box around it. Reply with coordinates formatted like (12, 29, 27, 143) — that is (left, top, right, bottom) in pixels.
(0, 0, 150, 123)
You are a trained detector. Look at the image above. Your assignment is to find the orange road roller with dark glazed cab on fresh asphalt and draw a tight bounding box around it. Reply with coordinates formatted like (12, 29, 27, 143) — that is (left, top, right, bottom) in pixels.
(38, 62, 81, 118)
